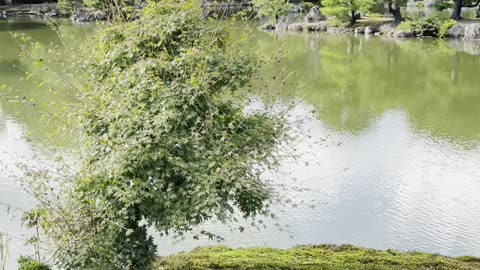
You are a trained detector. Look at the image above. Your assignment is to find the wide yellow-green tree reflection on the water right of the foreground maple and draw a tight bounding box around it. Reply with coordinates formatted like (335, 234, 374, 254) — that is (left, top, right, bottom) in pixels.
(256, 32, 480, 141)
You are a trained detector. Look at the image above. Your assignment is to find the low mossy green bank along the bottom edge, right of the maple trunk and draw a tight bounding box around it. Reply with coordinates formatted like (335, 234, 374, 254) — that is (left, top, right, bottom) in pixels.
(157, 245, 480, 270)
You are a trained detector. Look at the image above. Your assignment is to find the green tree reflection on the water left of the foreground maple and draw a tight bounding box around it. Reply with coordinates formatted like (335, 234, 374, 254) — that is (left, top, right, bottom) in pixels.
(0, 20, 94, 146)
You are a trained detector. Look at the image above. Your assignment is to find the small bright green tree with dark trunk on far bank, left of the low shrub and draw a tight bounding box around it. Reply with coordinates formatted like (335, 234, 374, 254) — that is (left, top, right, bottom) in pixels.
(321, 0, 375, 24)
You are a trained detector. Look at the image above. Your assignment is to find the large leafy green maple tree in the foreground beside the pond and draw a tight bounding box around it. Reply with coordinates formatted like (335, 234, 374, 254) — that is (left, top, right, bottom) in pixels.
(20, 1, 285, 270)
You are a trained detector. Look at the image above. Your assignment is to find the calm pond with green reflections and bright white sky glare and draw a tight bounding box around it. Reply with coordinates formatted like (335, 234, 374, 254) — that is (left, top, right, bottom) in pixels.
(0, 17, 480, 269)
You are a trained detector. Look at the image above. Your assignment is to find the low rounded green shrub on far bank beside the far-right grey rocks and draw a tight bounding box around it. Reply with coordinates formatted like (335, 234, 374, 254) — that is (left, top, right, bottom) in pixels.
(397, 16, 455, 37)
